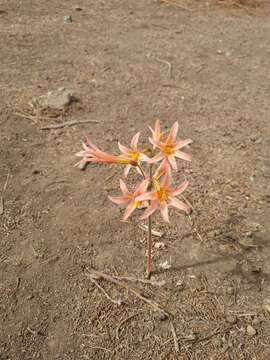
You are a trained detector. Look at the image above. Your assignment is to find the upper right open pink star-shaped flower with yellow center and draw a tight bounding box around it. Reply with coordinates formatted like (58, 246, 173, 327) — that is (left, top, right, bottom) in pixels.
(148, 121, 192, 171)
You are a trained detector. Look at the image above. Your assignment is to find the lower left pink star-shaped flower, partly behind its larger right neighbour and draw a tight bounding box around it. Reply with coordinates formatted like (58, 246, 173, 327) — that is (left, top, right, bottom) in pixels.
(109, 179, 149, 220)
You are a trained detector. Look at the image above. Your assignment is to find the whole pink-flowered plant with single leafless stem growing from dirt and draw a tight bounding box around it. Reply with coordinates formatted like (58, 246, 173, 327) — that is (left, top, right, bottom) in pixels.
(76, 120, 192, 278)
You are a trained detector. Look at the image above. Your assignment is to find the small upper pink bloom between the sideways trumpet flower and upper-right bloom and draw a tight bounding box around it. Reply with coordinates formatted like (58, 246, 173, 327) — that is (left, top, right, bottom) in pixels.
(118, 132, 149, 177)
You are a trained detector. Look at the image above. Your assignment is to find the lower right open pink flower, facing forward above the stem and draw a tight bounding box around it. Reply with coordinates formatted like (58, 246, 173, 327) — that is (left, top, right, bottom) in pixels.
(136, 173, 190, 222)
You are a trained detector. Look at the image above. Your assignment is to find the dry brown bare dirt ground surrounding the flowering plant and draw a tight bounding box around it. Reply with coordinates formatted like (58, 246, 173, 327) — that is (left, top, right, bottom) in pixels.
(0, 0, 270, 360)
